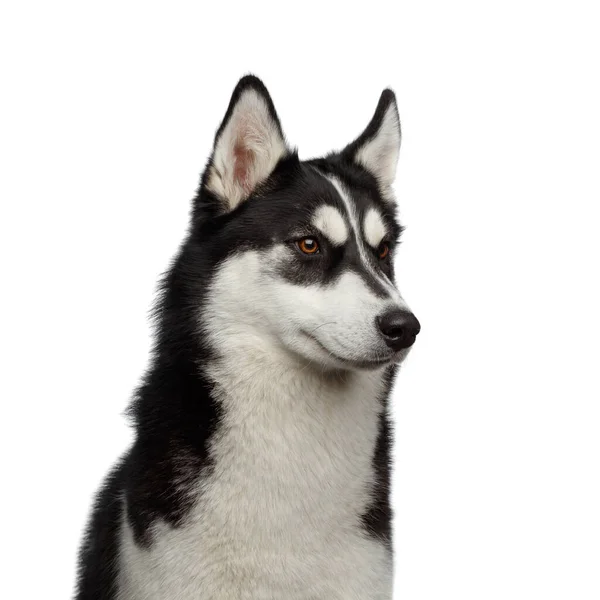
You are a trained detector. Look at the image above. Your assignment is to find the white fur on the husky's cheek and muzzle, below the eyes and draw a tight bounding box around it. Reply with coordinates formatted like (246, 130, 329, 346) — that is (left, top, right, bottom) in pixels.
(203, 244, 400, 369)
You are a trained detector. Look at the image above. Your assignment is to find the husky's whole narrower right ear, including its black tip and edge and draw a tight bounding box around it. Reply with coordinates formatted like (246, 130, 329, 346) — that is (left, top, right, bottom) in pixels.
(342, 89, 401, 197)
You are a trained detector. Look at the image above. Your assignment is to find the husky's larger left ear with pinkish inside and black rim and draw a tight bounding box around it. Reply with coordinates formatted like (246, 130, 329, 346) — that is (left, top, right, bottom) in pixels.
(203, 75, 290, 213)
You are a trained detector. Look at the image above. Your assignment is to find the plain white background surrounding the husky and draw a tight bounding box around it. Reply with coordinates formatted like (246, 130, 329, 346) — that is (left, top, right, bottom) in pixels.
(0, 0, 600, 600)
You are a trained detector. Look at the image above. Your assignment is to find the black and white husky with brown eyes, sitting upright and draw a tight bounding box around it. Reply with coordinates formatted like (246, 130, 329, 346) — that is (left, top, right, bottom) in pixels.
(75, 75, 420, 600)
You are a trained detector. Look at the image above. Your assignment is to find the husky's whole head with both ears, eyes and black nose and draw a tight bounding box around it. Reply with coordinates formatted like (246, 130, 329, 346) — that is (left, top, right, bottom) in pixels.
(194, 77, 419, 369)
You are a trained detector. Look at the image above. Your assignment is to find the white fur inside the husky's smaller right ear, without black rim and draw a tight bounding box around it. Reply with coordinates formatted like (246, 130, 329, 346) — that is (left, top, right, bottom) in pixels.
(356, 104, 400, 199)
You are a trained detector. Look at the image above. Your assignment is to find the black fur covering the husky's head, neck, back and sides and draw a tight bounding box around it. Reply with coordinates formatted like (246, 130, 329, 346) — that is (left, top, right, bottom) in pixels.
(75, 76, 401, 600)
